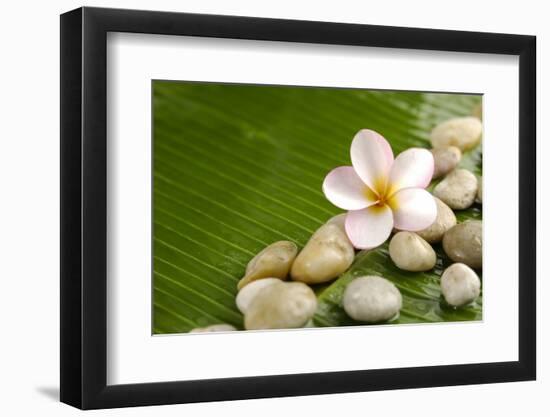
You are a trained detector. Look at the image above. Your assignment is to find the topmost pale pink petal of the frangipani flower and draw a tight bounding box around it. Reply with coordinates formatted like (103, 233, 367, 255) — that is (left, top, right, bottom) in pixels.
(350, 129, 393, 194)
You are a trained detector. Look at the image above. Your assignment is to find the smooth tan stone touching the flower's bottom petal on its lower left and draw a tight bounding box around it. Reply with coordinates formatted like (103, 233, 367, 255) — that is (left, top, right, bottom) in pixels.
(290, 222, 355, 284)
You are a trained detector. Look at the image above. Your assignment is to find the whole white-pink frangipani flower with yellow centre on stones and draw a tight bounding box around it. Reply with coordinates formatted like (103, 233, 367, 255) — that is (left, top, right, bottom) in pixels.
(323, 129, 437, 249)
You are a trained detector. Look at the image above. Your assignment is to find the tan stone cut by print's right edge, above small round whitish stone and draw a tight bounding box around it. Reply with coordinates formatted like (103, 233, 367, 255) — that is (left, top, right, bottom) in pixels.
(443, 220, 483, 269)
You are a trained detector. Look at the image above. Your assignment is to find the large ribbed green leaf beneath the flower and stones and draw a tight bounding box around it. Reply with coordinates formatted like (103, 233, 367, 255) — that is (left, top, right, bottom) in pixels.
(153, 81, 481, 333)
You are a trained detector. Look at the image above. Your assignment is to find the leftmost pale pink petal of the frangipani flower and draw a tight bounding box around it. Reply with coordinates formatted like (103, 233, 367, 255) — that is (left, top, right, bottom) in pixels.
(323, 167, 377, 210)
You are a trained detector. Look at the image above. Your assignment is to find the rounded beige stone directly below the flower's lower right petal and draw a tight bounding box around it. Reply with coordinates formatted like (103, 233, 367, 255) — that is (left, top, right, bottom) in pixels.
(389, 232, 437, 272)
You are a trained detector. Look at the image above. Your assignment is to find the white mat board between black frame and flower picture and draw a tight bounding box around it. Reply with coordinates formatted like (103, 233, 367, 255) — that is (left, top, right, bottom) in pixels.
(107, 34, 519, 384)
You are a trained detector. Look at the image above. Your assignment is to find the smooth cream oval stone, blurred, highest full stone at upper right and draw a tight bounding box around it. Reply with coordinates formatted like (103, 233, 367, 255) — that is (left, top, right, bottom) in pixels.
(430, 116, 483, 152)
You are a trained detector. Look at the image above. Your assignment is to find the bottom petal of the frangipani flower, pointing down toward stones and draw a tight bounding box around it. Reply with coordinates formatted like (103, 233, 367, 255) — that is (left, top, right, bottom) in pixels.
(346, 205, 393, 249)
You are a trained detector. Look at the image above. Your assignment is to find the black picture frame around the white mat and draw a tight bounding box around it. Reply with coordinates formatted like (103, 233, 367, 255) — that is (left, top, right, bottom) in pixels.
(60, 7, 536, 409)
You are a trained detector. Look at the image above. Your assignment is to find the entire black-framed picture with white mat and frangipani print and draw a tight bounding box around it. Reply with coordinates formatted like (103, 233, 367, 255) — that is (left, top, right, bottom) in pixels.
(60, 7, 536, 409)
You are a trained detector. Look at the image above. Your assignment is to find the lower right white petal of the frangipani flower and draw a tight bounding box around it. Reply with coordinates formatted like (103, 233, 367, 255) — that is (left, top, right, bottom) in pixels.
(388, 188, 437, 232)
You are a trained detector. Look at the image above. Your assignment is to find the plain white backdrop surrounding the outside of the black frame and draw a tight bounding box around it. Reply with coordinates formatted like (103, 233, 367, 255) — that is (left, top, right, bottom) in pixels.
(0, 0, 550, 416)
